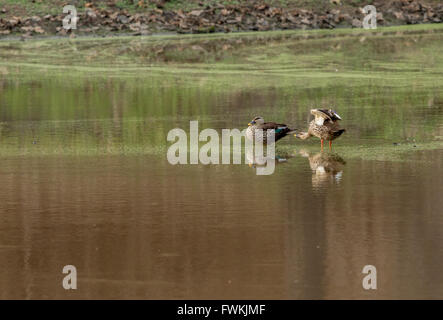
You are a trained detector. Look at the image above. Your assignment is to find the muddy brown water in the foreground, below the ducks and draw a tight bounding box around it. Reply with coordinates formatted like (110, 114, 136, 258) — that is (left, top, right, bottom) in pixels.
(0, 151, 443, 299)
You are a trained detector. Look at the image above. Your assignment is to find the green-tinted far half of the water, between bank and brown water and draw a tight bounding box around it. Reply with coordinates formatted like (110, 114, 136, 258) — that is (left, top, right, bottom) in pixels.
(0, 26, 443, 158)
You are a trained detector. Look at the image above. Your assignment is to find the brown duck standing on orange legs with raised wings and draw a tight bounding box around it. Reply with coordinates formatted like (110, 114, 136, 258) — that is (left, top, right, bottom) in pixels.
(294, 109, 346, 150)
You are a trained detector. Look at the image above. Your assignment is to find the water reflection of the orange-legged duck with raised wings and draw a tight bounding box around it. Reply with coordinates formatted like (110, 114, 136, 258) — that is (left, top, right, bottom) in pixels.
(299, 150, 346, 188)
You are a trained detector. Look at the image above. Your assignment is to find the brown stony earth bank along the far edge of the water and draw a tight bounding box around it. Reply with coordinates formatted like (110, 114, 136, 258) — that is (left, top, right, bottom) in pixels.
(0, 0, 443, 38)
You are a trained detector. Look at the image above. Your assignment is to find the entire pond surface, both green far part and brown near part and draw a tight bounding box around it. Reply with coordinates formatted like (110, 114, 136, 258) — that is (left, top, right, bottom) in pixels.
(0, 28, 443, 299)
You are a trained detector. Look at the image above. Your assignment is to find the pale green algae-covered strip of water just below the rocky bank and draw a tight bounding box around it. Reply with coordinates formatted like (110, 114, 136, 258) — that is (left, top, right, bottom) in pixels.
(0, 25, 443, 89)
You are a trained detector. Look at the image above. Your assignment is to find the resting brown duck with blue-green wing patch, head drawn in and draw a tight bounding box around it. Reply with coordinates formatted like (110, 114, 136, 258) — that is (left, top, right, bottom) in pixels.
(246, 117, 296, 144)
